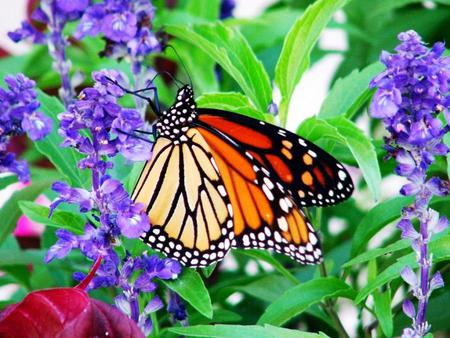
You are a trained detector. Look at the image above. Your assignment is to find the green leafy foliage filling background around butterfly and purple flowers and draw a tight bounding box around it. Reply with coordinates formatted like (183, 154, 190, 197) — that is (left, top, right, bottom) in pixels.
(0, 0, 450, 338)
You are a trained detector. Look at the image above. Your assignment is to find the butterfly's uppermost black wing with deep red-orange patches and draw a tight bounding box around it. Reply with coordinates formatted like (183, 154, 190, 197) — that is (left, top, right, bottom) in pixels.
(198, 109, 353, 207)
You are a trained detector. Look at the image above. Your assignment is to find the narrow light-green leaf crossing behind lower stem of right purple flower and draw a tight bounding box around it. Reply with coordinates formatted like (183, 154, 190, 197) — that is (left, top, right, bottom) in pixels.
(354, 235, 450, 304)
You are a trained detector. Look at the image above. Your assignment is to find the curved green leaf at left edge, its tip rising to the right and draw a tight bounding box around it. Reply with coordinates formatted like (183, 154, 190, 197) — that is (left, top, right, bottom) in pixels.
(0, 180, 51, 245)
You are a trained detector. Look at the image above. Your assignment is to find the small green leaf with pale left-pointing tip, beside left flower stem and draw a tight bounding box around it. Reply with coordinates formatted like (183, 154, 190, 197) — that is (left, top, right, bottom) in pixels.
(19, 201, 86, 234)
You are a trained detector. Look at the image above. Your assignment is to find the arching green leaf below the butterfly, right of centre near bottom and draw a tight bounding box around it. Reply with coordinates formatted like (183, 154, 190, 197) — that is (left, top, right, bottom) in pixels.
(258, 277, 356, 325)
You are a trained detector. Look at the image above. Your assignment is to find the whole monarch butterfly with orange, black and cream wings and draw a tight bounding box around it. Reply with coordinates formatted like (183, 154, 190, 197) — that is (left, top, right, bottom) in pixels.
(128, 85, 353, 267)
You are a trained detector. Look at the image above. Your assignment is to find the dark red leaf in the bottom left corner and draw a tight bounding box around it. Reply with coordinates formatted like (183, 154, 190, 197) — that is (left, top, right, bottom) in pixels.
(0, 288, 144, 338)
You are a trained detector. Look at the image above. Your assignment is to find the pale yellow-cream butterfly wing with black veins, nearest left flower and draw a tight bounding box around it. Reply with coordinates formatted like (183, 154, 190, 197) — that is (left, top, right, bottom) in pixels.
(132, 128, 234, 267)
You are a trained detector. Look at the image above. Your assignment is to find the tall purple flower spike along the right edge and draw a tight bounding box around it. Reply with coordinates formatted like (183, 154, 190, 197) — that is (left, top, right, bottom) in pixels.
(370, 31, 450, 337)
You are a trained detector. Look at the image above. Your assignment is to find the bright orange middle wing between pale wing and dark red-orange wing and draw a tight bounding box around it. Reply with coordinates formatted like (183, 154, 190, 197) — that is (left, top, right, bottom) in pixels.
(197, 123, 322, 264)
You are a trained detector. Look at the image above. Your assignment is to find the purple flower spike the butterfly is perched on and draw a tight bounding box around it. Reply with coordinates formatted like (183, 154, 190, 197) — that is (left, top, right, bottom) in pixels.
(46, 70, 181, 333)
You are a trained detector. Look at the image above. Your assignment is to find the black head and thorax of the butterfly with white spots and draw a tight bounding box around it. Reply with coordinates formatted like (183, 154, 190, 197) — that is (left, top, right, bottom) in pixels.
(156, 85, 197, 140)
